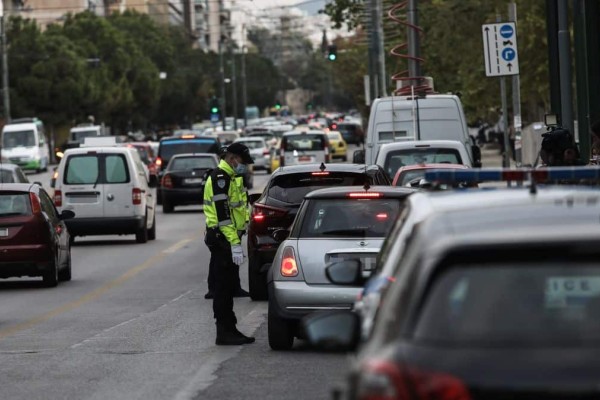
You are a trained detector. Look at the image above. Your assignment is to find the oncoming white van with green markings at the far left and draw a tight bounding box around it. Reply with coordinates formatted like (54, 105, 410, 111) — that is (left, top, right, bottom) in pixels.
(2, 118, 50, 172)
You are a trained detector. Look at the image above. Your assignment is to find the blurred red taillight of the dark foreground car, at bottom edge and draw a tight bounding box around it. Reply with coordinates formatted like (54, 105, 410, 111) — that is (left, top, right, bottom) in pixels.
(356, 361, 471, 400)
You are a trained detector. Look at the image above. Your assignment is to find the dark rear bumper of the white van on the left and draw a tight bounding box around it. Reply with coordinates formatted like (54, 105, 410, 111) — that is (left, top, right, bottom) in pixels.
(65, 215, 144, 236)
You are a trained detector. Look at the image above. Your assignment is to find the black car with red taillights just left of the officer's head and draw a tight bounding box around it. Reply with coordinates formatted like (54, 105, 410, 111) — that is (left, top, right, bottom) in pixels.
(161, 153, 219, 214)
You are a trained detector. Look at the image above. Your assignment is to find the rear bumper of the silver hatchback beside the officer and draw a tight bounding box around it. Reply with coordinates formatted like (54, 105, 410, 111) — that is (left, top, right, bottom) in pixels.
(269, 281, 362, 319)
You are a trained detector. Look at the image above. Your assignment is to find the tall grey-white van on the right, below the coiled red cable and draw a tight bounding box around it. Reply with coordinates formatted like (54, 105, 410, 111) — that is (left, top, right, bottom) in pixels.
(355, 94, 481, 167)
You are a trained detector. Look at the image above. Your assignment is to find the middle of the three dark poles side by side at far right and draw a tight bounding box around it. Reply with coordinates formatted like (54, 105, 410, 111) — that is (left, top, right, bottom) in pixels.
(558, 0, 573, 133)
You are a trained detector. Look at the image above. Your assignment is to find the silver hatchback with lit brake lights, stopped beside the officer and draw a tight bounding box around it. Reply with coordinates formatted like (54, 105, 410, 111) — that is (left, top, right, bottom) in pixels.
(267, 186, 415, 350)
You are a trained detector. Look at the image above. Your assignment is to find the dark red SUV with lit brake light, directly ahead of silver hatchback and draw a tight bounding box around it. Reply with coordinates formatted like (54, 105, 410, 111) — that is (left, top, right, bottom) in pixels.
(248, 163, 391, 300)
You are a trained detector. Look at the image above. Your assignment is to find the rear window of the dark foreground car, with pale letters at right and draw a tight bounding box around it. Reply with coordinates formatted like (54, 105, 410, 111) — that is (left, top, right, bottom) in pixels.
(414, 261, 600, 346)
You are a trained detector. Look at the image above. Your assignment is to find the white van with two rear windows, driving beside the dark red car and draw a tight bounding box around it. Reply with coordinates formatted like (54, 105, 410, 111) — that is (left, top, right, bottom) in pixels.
(54, 146, 158, 243)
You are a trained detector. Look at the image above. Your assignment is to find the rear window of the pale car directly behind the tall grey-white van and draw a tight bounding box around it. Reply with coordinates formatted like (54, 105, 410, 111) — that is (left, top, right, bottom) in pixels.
(383, 147, 462, 178)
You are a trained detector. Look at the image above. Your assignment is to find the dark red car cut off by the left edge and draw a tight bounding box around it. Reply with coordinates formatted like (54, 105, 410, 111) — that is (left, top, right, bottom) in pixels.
(0, 183, 75, 287)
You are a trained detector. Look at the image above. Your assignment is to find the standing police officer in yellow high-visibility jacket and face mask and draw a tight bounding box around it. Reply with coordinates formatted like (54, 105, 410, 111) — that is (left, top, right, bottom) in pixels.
(204, 143, 254, 345)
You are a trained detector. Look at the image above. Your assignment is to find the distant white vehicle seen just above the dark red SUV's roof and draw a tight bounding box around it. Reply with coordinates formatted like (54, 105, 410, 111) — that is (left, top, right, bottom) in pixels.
(279, 130, 330, 167)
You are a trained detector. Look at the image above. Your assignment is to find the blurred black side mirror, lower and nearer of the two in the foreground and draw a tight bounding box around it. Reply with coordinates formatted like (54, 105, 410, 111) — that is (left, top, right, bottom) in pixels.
(300, 310, 360, 351)
